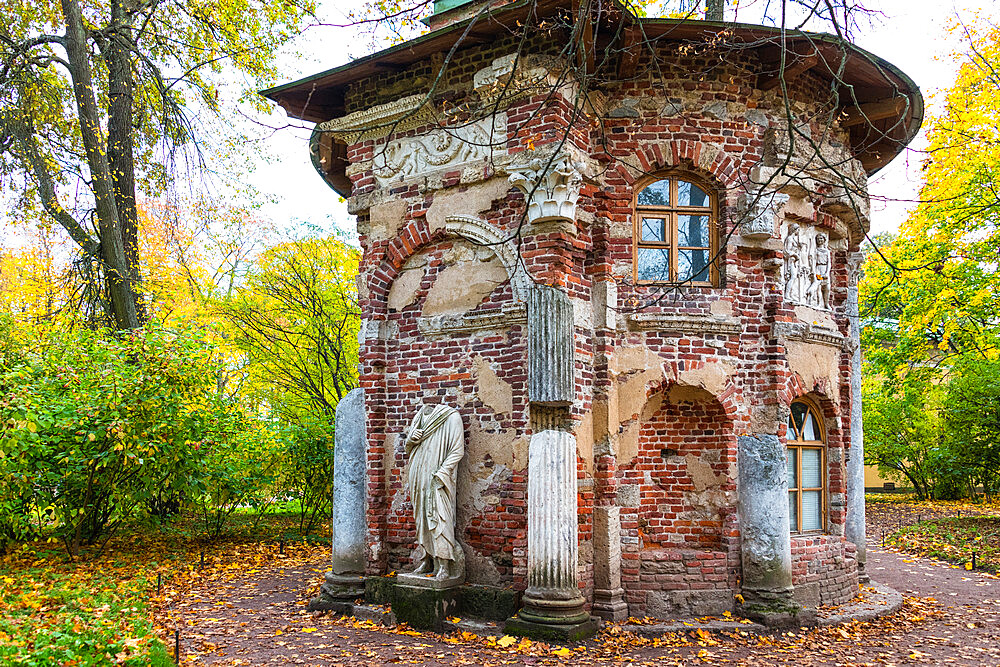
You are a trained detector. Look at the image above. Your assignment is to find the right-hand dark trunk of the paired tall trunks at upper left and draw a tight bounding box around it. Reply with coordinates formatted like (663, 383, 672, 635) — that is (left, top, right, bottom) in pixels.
(104, 0, 146, 324)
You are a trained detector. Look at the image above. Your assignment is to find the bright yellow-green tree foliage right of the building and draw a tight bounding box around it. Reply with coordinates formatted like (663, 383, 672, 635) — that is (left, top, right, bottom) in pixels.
(860, 28, 1000, 497)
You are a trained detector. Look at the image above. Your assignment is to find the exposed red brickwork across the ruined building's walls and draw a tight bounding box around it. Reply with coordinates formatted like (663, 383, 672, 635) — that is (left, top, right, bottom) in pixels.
(348, 36, 856, 615)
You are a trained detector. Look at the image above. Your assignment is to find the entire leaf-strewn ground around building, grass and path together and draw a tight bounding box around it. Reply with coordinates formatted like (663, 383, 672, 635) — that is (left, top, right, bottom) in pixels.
(0, 500, 1000, 667)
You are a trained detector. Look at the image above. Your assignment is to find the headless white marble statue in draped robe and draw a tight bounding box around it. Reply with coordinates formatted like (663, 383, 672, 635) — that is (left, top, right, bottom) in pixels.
(406, 405, 465, 579)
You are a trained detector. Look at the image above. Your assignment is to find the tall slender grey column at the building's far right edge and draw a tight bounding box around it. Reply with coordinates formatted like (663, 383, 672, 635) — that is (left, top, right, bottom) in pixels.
(845, 252, 868, 581)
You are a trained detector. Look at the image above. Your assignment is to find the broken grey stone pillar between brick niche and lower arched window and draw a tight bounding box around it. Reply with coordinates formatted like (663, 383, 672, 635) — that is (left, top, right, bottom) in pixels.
(738, 434, 795, 612)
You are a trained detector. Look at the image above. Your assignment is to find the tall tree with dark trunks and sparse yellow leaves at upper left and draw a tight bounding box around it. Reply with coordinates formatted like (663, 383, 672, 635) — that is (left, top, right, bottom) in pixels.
(0, 0, 313, 329)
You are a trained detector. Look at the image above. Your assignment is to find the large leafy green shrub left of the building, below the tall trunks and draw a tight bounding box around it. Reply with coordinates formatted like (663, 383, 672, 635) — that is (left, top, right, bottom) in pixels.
(0, 321, 274, 555)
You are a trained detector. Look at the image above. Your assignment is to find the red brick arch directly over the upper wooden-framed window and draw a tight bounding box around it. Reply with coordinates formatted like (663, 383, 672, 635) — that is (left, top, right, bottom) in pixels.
(617, 139, 740, 191)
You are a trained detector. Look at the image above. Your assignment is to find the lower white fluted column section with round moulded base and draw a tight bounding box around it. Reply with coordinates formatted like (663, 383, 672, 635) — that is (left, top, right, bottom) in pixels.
(505, 430, 597, 640)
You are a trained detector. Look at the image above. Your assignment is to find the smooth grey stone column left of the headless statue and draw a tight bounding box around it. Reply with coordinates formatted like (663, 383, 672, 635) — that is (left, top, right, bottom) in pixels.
(310, 389, 368, 611)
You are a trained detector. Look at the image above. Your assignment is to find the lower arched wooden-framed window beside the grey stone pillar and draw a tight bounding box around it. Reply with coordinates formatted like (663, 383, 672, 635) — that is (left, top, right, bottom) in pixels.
(787, 401, 826, 533)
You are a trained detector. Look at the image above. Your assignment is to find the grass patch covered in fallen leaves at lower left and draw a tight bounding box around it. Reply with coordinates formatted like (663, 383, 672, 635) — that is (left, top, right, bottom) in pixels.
(0, 514, 328, 667)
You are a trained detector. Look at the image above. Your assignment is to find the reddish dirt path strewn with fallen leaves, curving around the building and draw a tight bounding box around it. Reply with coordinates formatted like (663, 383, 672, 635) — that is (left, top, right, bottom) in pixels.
(158, 512, 1000, 667)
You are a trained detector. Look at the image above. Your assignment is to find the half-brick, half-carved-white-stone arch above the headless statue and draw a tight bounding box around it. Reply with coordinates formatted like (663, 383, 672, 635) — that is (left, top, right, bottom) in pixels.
(369, 215, 530, 314)
